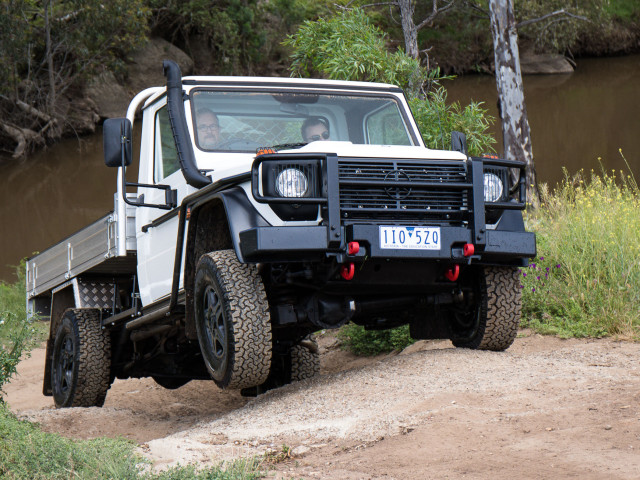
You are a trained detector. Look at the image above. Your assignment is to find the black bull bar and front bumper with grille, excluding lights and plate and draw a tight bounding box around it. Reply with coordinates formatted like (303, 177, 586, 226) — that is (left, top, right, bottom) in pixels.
(239, 154, 536, 265)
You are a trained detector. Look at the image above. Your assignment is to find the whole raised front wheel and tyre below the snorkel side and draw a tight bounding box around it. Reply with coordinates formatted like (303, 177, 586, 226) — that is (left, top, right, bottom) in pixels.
(194, 250, 272, 389)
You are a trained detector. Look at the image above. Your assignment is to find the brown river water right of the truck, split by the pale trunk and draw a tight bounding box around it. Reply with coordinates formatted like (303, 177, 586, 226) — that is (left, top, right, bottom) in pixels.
(445, 55, 640, 186)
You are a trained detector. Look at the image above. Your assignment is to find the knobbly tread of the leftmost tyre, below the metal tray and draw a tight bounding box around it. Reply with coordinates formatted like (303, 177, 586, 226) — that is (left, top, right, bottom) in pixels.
(56, 308, 111, 408)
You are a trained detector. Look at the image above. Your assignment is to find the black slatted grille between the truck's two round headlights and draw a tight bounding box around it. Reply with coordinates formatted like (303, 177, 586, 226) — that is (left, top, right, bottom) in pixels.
(338, 160, 471, 221)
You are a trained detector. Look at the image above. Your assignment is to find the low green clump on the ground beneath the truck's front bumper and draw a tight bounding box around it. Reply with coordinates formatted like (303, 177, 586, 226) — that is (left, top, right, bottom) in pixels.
(338, 323, 415, 355)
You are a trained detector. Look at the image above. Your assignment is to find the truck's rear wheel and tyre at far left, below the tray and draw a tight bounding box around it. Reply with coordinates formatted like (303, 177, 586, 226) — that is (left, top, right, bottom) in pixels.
(51, 308, 111, 408)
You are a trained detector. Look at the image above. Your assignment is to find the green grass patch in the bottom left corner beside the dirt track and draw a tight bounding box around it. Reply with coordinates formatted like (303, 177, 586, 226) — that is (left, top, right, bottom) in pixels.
(0, 404, 262, 480)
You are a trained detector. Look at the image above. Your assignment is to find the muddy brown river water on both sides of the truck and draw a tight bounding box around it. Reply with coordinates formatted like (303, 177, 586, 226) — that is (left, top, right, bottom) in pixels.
(0, 55, 640, 281)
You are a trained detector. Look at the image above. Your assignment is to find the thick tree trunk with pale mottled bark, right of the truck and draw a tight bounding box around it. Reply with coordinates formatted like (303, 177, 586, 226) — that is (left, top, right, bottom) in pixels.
(489, 0, 540, 208)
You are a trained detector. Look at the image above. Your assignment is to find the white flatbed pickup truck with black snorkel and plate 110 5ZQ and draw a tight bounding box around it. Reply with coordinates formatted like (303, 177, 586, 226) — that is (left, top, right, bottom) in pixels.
(27, 61, 536, 407)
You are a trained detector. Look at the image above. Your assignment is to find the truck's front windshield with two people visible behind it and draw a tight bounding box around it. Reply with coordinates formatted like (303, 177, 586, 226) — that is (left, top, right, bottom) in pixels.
(191, 89, 416, 152)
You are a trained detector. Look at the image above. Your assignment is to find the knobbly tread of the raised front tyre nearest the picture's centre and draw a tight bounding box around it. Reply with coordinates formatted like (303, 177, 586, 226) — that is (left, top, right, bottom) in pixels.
(196, 250, 272, 389)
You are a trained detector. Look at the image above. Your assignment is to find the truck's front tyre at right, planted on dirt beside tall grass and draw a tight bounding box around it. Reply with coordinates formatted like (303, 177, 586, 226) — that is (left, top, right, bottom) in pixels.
(451, 267, 522, 351)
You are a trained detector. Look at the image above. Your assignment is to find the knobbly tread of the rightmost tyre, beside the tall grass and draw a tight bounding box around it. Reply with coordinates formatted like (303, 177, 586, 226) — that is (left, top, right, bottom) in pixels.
(454, 267, 522, 351)
